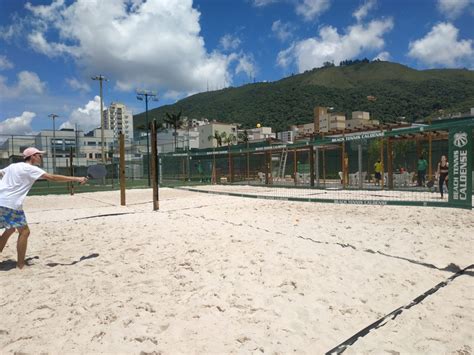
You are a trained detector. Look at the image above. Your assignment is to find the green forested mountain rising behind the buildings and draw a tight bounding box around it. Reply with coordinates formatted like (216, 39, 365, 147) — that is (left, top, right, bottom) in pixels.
(134, 61, 474, 131)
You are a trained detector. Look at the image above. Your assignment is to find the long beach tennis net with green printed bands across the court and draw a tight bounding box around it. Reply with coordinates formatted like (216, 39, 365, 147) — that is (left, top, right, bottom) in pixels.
(160, 119, 474, 208)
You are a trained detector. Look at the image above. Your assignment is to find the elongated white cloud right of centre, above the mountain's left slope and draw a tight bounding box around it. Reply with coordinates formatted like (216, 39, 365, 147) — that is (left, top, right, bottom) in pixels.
(277, 19, 393, 72)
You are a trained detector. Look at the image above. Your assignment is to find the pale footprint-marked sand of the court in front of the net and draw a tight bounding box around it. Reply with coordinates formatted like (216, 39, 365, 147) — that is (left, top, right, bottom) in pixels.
(0, 189, 474, 354)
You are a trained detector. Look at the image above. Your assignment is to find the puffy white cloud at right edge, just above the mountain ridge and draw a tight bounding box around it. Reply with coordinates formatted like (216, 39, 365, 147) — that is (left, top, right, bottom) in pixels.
(408, 22, 474, 67)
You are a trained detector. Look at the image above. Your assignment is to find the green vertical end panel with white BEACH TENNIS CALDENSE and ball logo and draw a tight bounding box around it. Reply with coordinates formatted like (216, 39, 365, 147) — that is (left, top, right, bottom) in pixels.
(449, 128, 472, 208)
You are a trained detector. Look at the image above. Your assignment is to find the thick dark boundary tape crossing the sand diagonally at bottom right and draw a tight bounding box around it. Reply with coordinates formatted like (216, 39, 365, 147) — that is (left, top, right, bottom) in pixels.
(325, 264, 474, 355)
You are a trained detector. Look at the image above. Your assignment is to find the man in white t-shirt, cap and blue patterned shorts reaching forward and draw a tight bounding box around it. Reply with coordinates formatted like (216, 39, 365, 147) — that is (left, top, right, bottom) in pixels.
(0, 147, 87, 269)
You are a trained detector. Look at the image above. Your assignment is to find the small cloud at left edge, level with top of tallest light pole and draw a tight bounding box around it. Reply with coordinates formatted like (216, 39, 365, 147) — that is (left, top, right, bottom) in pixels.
(0, 70, 46, 98)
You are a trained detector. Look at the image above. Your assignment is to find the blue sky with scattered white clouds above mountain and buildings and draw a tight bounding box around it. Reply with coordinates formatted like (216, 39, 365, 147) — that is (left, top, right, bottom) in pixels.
(0, 0, 474, 134)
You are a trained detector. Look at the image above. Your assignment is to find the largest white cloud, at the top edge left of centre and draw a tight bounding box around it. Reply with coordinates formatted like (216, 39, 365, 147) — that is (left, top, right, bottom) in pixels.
(21, 0, 252, 96)
